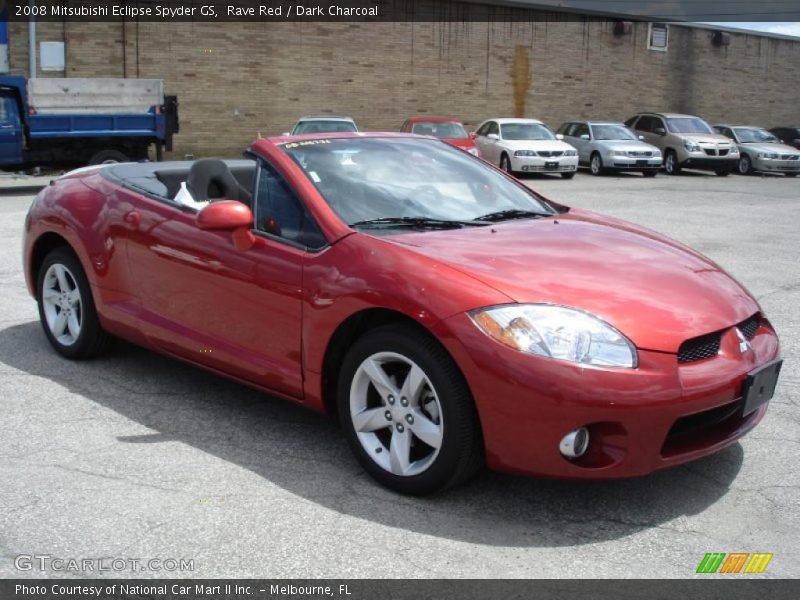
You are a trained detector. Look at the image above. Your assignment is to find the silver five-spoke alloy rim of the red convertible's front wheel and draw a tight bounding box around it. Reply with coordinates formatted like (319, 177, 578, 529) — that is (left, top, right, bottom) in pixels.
(350, 352, 444, 477)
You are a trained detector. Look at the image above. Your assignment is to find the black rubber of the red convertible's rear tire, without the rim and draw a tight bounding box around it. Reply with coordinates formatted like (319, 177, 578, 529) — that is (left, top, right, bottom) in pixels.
(36, 247, 111, 360)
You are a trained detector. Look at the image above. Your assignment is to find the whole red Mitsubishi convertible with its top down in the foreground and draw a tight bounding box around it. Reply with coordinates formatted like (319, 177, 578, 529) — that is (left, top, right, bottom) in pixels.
(24, 133, 781, 494)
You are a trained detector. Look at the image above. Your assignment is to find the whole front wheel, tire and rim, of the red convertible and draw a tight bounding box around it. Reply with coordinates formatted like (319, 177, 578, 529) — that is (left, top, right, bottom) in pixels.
(338, 325, 483, 495)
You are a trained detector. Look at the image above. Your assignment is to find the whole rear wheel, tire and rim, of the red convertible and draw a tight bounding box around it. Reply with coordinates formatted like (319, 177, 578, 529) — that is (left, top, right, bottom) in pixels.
(36, 248, 110, 359)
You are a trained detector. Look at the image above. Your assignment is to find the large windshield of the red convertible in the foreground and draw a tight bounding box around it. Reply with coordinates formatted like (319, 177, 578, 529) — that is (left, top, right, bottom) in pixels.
(282, 138, 555, 231)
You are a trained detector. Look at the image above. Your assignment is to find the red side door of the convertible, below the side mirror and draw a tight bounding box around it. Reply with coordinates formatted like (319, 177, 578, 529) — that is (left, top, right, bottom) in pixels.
(128, 162, 312, 398)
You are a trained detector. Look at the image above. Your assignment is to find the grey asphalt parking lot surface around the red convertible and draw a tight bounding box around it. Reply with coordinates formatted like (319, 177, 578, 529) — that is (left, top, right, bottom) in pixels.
(0, 173, 800, 578)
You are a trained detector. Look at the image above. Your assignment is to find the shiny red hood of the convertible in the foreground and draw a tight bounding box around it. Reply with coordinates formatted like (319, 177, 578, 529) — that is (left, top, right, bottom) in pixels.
(382, 209, 759, 353)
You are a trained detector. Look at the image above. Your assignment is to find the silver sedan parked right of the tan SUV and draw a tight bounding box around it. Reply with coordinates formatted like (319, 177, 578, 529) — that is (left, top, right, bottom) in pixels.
(714, 125, 800, 177)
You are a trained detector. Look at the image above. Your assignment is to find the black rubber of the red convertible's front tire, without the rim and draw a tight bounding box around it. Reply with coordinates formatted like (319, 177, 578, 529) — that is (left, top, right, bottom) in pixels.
(337, 325, 484, 496)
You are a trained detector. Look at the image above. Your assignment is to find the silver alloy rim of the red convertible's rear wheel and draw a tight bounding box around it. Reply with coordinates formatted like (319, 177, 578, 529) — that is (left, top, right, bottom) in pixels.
(41, 263, 83, 346)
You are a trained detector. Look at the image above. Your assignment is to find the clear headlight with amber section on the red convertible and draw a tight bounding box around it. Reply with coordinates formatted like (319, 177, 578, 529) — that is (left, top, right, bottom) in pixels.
(470, 304, 638, 368)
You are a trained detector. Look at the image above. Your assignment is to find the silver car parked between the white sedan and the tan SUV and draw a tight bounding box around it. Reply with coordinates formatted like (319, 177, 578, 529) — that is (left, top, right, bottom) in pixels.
(558, 121, 661, 177)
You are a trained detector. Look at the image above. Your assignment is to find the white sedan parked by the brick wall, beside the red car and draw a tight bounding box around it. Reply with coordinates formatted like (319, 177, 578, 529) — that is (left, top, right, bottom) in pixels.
(475, 119, 578, 179)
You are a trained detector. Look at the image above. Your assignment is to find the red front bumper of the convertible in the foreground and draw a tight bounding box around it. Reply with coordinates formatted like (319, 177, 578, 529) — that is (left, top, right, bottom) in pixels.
(436, 314, 779, 479)
